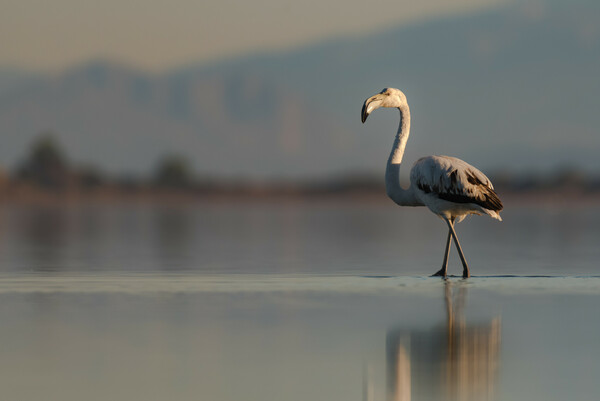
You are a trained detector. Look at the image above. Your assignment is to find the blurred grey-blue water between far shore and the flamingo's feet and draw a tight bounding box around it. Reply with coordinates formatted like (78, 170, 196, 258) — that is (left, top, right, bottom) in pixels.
(0, 202, 600, 275)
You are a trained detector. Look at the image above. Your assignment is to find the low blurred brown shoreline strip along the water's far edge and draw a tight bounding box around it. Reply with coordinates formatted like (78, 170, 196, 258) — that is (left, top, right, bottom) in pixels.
(0, 181, 600, 206)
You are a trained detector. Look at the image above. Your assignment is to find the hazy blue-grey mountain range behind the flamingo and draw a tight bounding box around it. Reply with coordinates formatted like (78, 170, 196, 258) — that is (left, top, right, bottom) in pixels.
(0, 1, 600, 178)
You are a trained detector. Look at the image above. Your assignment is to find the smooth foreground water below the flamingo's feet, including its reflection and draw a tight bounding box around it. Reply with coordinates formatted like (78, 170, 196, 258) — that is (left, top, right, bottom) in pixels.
(0, 273, 600, 401)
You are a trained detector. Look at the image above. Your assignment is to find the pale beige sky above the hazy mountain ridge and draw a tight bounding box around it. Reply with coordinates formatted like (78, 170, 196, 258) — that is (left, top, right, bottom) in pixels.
(0, 0, 510, 72)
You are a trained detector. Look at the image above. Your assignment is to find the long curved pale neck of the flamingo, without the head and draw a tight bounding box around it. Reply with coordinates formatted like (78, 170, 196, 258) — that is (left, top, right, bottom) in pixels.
(385, 105, 422, 206)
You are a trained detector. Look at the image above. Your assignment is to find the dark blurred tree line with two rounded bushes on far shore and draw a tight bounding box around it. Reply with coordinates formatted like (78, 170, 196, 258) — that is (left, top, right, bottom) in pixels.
(1, 133, 600, 195)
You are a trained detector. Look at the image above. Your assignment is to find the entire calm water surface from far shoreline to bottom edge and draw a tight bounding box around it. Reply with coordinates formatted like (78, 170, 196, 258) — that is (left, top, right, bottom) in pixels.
(0, 202, 600, 401)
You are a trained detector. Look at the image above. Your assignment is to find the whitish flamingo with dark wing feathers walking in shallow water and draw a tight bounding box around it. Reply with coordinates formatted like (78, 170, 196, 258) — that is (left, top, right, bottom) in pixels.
(361, 88, 503, 278)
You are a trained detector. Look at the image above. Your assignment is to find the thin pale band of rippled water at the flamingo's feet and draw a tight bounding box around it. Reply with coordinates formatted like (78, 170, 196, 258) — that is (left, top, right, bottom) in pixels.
(0, 273, 600, 295)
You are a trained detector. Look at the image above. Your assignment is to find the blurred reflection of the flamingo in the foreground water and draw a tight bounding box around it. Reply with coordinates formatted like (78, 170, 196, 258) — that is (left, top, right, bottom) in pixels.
(386, 281, 500, 401)
